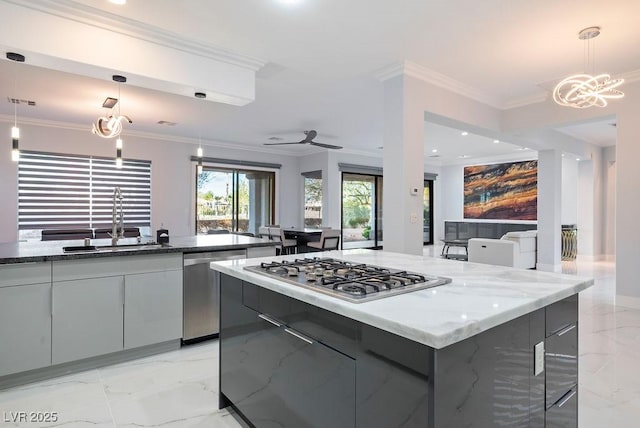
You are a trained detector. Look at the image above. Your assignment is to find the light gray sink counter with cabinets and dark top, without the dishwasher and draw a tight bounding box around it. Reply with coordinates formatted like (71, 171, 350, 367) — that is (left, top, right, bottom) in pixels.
(0, 234, 275, 389)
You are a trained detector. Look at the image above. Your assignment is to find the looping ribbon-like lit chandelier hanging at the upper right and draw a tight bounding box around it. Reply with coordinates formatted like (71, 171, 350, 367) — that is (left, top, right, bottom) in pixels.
(553, 27, 624, 108)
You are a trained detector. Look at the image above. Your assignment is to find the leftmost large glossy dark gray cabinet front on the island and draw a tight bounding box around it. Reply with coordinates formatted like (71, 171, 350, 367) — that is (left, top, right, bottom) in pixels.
(221, 276, 356, 428)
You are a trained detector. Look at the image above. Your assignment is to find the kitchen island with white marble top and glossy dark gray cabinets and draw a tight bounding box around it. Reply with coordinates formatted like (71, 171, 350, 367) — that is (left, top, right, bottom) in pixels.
(211, 250, 593, 428)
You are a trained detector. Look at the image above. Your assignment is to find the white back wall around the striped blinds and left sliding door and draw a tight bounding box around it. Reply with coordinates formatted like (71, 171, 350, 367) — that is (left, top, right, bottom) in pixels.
(0, 123, 302, 242)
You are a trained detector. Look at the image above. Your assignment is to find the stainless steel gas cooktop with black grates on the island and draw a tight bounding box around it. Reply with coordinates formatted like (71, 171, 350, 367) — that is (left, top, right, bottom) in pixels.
(245, 257, 451, 303)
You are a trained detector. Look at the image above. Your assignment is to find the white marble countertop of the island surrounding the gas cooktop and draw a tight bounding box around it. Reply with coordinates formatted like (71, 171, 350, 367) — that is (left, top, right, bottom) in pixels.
(211, 250, 593, 349)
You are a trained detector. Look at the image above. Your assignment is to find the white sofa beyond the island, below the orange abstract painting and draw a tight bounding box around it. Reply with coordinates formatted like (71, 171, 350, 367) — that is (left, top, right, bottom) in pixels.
(468, 230, 537, 269)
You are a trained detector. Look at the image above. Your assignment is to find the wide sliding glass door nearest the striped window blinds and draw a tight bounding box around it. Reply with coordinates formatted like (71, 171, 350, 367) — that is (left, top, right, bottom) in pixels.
(196, 166, 275, 234)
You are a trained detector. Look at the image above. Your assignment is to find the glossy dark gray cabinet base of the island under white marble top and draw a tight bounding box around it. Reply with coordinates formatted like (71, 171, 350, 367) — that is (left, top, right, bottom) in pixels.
(219, 274, 578, 428)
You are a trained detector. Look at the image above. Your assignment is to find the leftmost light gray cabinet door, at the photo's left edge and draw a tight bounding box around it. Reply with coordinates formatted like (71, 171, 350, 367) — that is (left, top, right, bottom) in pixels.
(0, 282, 51, 376)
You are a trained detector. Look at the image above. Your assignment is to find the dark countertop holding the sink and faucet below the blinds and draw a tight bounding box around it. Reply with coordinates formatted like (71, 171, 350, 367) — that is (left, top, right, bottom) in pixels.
(0, 233, 276, 265)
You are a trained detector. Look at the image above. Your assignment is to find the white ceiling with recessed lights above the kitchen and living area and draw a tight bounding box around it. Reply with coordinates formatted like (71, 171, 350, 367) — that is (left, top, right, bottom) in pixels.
(0, 0, 640, 163)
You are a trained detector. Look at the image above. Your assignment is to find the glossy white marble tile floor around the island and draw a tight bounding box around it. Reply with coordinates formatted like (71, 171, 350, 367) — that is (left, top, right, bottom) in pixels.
(0, 246, 640, 428)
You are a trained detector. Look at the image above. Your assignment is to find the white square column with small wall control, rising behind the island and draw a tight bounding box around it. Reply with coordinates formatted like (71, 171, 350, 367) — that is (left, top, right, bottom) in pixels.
(382, 75, 424, 255)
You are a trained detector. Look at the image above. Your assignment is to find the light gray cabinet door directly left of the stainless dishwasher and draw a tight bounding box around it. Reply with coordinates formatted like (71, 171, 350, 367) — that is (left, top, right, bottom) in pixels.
(124, 270, 182, 349)
